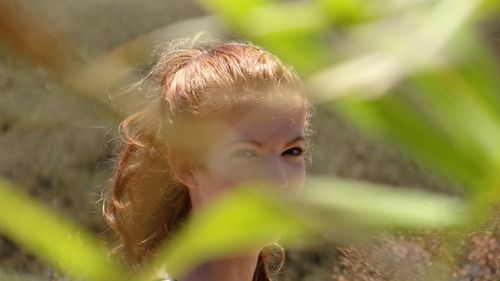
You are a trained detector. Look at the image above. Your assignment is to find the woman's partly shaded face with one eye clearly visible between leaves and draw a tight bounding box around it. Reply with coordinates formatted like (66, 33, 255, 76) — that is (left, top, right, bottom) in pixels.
(183, 106, 306, 209)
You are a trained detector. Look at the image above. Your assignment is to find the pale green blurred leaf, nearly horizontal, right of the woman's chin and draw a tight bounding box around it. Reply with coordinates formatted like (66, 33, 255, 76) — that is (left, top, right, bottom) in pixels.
(299, 177, 467, 229)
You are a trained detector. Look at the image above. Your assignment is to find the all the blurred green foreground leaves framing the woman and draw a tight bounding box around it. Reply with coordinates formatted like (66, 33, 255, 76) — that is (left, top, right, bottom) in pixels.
(0, 0, 500, 281)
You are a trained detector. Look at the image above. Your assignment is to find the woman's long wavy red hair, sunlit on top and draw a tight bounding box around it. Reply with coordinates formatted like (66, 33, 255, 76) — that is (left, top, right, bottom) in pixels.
(103, 35, 307, 281)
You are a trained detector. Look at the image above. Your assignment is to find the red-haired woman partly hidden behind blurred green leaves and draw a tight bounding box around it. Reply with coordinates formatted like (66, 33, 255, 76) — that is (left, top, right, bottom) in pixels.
(104, 37, 308, 281)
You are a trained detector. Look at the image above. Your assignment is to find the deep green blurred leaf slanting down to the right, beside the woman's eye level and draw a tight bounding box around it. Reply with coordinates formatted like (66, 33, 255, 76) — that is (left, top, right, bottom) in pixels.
(334, 90, 483, 186)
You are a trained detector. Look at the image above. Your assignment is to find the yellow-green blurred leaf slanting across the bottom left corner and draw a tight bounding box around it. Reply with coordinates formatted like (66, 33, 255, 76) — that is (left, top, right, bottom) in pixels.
(0, 179, 127, 281)
